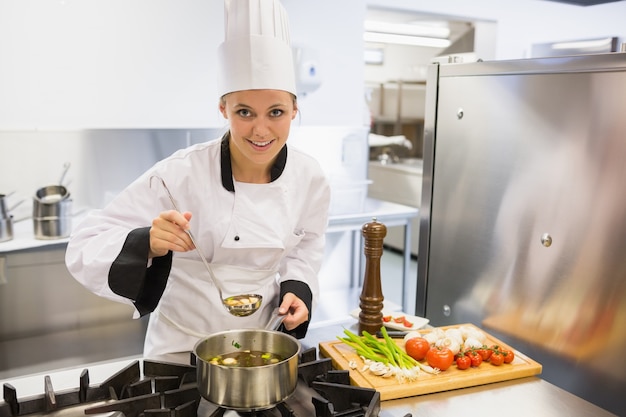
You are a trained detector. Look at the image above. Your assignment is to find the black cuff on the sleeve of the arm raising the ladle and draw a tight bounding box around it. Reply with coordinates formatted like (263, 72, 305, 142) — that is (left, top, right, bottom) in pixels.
(109, 227, 172, 316)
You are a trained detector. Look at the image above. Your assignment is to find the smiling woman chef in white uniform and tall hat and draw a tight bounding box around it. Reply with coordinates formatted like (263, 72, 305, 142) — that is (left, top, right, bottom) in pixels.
(66, 0, 330, 357)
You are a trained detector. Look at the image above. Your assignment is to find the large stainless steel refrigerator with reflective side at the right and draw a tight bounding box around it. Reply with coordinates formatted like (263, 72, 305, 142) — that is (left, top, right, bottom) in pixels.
(416, 53, 626, 415)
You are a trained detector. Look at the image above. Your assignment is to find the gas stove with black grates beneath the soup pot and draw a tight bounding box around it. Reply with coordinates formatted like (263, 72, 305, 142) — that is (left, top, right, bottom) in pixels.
(0, 348, 380, 417)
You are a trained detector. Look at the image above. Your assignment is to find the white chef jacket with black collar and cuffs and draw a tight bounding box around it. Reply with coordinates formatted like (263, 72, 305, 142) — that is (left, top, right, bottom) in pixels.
(66, 134, 330, 357)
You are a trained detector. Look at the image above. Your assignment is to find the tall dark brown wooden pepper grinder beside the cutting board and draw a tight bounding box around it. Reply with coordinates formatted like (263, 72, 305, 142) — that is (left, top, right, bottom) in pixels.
(359, 218, 387, 334)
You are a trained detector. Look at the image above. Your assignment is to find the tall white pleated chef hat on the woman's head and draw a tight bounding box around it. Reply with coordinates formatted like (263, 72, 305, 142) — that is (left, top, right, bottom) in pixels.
(217, 0, 296, 97)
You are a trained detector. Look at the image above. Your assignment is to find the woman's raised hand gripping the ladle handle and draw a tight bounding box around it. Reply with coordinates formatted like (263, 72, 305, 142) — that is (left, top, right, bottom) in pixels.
(149, 210, 194, 258)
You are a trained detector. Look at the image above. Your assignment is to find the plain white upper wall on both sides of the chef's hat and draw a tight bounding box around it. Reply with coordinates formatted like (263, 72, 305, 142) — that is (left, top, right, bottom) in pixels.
(0, 0, 364, 130)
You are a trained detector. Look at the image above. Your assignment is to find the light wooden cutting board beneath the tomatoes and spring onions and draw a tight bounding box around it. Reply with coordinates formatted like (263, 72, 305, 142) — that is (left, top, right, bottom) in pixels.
(319, 324, 541, 401)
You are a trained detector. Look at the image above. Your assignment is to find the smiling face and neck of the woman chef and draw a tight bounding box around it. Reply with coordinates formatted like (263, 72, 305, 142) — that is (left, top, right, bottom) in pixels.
(220, 90, 297, 182)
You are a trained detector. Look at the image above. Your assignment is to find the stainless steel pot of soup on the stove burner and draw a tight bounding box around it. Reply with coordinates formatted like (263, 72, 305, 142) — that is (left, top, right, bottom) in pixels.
(194, 329, 300, 411)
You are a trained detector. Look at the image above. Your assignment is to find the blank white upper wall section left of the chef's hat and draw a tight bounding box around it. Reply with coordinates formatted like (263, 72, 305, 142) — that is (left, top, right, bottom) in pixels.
(0, 0, 223, 129)
